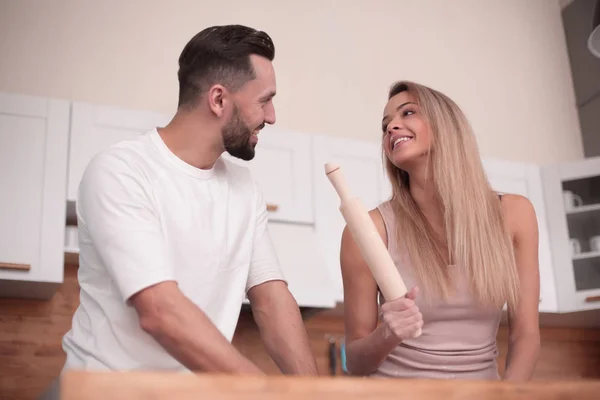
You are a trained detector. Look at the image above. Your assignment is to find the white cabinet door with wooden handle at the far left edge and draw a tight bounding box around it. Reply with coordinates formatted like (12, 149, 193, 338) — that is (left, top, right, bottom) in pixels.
(0, 93, 69, 294)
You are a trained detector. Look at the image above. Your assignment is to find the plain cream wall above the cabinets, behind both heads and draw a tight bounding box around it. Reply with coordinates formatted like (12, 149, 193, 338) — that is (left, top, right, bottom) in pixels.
(0, 0, 583, 163)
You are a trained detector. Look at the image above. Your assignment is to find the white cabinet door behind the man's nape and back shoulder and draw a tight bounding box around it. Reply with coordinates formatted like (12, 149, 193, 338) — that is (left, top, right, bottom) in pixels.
(67, 102, 170, 201)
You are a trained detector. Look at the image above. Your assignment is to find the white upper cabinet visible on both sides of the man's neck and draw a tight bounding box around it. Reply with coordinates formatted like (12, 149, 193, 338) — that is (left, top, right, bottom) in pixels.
(68, 102, 313, 223)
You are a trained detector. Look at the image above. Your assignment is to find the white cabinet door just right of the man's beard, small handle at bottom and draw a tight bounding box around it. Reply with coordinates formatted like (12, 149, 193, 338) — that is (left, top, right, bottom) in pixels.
(223, 126, 314, 224)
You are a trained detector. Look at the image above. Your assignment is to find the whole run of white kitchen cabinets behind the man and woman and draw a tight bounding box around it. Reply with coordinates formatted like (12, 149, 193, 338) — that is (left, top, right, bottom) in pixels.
(0, 89, 600, 315)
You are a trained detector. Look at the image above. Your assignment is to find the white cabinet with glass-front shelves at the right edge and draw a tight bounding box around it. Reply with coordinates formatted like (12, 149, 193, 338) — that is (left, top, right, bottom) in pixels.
(541, 157, 600, 312)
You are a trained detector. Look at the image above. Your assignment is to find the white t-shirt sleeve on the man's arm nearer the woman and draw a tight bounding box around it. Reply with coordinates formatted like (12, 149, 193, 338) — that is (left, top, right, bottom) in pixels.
(246, 183, 287, 291)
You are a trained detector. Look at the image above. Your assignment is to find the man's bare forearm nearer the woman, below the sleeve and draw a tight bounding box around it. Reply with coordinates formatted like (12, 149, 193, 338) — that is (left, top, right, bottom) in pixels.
(252, 282, 318, 375)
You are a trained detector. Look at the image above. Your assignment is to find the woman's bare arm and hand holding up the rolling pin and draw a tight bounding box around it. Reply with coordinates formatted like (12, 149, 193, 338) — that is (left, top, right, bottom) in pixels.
(340, 210, 422, 375)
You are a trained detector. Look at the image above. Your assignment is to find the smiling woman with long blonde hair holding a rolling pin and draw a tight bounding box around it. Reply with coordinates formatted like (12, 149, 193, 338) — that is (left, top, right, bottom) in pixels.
(341, 81, 540, 381)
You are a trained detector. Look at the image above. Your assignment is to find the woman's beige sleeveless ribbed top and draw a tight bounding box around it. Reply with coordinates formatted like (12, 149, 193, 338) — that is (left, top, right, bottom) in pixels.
(371, 201, 502, 380)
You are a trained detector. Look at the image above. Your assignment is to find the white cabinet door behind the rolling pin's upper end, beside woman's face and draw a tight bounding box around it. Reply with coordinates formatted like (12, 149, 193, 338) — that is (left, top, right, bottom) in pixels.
(312, 136, 389, 301)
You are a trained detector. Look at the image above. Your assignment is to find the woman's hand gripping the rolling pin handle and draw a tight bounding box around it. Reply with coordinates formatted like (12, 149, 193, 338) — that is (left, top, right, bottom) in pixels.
(380, 287, 423, 343)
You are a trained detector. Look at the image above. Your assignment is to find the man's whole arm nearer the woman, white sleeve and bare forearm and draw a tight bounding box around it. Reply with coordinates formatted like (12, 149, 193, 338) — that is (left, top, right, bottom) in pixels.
(246, 179, 318, 375)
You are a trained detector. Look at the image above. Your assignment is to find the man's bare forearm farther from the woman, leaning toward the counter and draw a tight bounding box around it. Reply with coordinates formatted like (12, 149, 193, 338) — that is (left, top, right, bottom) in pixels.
(140, 288, 263, 374)
